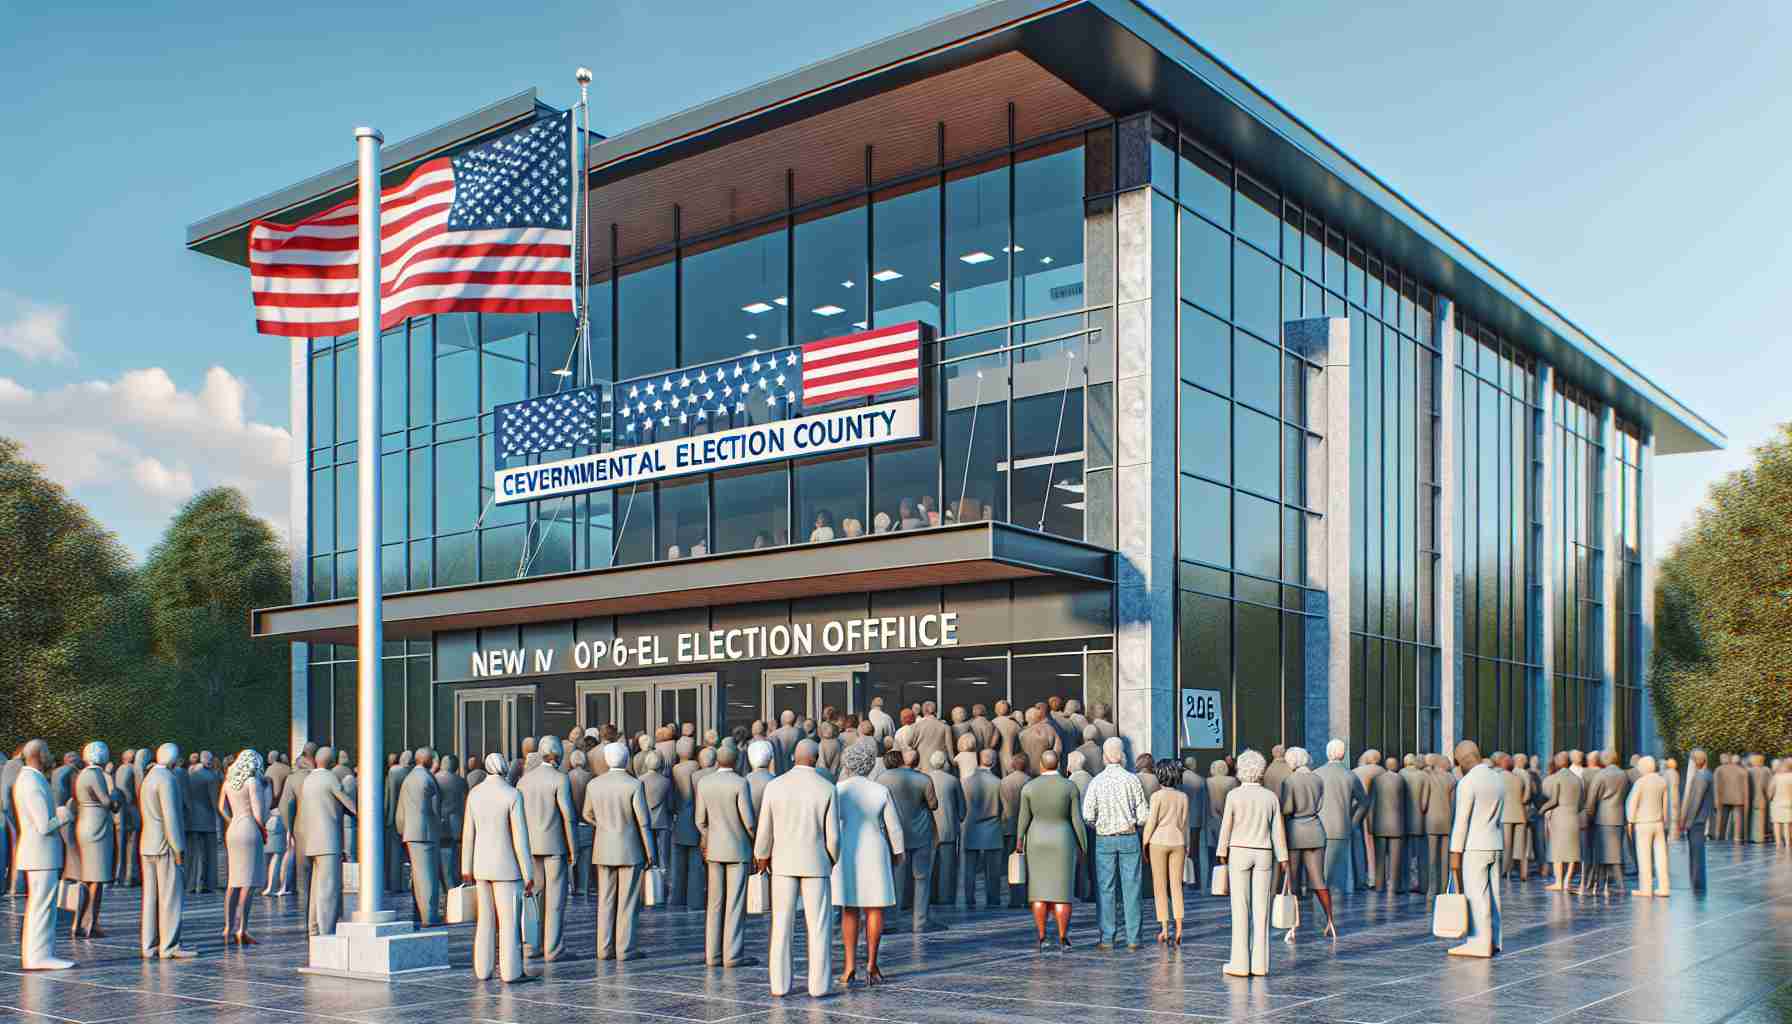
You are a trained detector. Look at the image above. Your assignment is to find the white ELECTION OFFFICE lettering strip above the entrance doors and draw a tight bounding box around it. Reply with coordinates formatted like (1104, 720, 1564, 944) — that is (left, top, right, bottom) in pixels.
(471, 612, 959, 680)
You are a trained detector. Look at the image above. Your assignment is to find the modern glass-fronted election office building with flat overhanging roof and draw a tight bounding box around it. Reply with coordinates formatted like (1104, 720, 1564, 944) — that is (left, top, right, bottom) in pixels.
(186, 0, 1724, 767)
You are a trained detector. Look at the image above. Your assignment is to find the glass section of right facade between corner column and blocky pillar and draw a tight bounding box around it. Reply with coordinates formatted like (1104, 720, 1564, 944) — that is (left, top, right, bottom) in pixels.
(1150, 124, 1340, 750)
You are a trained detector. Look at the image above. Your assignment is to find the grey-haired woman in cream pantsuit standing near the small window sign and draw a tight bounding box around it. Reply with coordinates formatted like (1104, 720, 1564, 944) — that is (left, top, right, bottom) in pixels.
(1217, 750, 1288, 977)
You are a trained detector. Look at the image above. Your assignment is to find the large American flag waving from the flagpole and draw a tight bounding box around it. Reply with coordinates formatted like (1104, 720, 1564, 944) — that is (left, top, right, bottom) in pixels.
(249, 113, 573, 337)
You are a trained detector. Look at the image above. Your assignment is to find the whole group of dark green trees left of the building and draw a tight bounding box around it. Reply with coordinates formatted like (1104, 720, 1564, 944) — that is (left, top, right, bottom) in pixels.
(0, 438, 290, 753)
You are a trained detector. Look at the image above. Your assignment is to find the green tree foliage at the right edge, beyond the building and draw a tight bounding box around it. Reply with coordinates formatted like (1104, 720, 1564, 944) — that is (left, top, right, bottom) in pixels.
(1650, 425, 1792, 753)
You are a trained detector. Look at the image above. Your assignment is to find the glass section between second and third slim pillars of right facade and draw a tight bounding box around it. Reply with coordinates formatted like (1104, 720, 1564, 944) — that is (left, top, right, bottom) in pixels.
(1550, 386, 1606, 750)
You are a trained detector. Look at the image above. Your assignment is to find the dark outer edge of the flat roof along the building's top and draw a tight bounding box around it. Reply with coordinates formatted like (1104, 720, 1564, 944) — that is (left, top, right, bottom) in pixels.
(186, 0, 1726, 454)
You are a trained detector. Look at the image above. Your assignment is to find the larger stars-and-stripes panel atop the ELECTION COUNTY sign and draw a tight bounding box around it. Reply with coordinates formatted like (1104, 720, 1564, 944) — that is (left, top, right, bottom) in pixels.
(615, 323, 925, 447)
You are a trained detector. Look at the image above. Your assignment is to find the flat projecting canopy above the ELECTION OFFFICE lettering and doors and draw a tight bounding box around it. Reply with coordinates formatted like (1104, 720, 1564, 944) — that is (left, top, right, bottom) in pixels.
(251, 522, 1115, 644)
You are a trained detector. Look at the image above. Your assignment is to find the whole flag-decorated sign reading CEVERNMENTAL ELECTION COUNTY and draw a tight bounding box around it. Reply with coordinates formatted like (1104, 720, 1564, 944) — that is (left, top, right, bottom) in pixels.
(493, 321, 932, 506)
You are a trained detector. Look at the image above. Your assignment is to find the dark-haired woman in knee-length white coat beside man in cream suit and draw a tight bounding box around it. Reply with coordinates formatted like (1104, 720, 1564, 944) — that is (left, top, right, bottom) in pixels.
(828, 742, 903, 986)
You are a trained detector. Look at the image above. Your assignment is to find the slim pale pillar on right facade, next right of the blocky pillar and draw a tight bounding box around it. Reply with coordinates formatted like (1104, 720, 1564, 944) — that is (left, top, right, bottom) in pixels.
(1432, 296, 1462, 753)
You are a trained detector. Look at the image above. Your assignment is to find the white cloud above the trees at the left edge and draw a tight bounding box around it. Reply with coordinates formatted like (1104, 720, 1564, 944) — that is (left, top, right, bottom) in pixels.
(0, 366, 292, 548)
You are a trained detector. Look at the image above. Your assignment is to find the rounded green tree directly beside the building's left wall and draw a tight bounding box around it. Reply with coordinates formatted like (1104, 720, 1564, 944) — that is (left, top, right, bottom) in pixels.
(142, 488, 292, 753)
